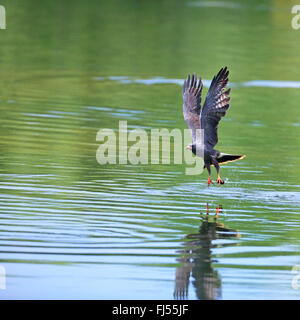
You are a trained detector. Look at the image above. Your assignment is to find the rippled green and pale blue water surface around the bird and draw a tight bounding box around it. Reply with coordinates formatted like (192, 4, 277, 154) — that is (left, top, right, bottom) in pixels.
(0, 0, 300, 299)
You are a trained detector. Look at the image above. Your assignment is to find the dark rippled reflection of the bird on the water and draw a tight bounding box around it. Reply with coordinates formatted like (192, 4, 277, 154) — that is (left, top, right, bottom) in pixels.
(174, 205, 240, 300)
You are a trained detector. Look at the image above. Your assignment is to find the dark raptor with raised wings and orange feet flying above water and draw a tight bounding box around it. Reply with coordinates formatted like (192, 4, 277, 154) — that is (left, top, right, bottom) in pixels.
(182, 67, 245, 186)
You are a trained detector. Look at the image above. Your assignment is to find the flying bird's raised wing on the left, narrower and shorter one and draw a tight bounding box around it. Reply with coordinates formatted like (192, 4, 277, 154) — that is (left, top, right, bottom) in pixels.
(182, 74, 203, 143)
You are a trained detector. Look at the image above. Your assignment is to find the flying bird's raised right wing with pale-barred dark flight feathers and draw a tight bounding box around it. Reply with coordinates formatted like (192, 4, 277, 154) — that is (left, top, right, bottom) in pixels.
(200, 67, 230, 148)
